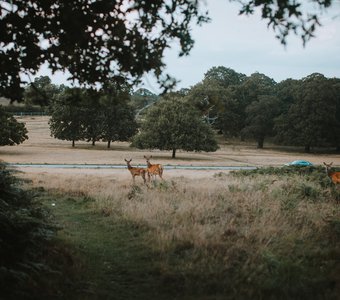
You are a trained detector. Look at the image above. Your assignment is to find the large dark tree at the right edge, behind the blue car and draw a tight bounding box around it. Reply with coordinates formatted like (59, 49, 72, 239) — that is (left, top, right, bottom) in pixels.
(275, 73, 339, 152)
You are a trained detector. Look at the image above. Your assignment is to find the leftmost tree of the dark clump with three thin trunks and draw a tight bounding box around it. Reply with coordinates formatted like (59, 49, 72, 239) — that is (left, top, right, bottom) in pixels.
(49, 88, 85, 147)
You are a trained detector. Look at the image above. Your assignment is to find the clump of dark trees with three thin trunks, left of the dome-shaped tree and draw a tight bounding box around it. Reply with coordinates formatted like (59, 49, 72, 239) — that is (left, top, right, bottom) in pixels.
(49, 84, 137, 148)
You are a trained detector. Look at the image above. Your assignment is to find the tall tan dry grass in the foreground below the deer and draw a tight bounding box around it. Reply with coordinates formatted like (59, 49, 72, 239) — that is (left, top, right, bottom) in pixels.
(24, 173, 340, 299)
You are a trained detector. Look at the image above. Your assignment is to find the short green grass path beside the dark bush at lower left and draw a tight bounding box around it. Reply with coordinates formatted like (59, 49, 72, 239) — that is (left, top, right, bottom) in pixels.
(43, 196, 174, 299)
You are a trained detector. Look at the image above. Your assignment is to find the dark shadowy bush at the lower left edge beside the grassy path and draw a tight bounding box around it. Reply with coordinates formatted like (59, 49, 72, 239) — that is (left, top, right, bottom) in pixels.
(0, 164, 56, 299)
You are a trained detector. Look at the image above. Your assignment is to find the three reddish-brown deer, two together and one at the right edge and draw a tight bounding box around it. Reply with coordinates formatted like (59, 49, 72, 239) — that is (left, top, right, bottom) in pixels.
(125, 159, 340, 184)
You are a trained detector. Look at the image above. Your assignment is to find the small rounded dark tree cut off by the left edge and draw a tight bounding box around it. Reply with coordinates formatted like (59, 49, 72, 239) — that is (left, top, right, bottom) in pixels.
(0, 105, 28, 146)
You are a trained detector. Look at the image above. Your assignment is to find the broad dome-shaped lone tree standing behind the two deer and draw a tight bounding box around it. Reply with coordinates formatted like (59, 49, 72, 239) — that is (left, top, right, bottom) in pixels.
(132, 98, 218, 158)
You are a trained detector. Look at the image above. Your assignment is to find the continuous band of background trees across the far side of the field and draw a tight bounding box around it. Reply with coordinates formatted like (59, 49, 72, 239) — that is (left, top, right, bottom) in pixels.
(2, 66, 340, 156)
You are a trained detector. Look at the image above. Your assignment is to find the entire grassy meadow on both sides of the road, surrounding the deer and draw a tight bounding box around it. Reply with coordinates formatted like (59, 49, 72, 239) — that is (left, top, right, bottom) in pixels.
(0, 117, 340, 299)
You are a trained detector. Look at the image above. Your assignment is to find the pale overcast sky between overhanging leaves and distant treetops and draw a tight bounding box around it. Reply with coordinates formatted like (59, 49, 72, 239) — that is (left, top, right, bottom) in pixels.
(39, 0, 340, 93)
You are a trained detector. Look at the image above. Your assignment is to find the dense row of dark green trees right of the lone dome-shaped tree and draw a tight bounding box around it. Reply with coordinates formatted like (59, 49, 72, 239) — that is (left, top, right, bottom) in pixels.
(183, 67, 340, 152)
